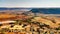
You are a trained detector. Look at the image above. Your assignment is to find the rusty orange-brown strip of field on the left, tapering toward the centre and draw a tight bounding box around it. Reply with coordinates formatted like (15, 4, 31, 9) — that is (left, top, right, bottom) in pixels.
(0, 14, 29, 21)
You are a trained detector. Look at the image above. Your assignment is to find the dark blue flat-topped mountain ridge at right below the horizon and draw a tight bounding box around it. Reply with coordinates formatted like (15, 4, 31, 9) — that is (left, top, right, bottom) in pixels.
(31, 8, 60, 14)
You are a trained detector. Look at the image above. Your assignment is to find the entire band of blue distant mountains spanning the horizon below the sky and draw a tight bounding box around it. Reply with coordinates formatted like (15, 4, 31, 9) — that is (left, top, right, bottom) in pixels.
(0, 8, 60, 14)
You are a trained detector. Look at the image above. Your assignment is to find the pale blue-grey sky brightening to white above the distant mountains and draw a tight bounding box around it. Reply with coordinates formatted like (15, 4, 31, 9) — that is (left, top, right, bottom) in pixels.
(0, 0, 60, 8)
